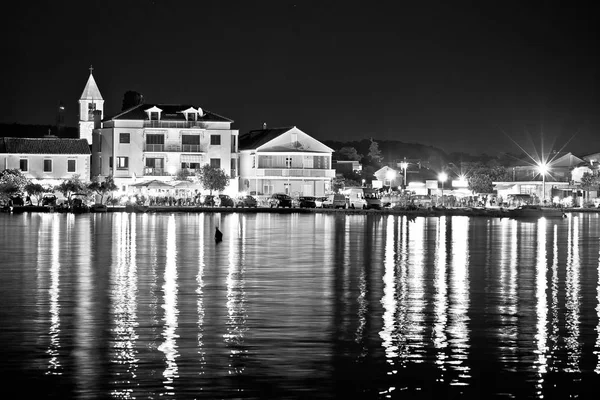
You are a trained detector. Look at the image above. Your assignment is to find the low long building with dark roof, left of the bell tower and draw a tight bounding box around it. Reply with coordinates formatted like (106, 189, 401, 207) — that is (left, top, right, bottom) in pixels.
(0, 136, 90, 186)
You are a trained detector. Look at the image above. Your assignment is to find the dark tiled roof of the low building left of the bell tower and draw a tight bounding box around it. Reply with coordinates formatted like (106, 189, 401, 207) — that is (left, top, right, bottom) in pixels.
(0, 137, 91, 155)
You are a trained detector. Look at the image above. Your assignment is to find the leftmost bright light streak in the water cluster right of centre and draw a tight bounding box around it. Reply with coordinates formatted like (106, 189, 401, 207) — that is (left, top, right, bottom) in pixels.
(379, 215, 400, 376)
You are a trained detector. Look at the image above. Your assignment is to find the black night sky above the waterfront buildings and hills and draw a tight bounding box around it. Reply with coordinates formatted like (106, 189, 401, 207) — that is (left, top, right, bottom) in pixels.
(0, 0, 600, 155)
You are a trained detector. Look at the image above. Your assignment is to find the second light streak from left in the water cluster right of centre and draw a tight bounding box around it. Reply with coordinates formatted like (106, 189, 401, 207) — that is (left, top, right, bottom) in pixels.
(407, 218, 428, 363)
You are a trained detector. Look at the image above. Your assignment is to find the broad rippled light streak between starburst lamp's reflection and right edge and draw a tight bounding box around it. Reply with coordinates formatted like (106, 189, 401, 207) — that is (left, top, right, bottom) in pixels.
(565, 217, 581, 372)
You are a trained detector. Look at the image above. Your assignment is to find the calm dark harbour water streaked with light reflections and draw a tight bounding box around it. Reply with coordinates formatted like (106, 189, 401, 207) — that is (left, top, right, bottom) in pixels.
(0, 213, 600, 399)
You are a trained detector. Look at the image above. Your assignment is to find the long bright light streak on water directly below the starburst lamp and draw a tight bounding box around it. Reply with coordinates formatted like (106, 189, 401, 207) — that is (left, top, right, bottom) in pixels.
(535, 218, 548, 398)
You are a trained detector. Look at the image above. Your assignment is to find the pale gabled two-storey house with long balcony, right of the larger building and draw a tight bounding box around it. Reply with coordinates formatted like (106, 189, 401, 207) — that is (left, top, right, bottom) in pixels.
(239, 126, 335, 196)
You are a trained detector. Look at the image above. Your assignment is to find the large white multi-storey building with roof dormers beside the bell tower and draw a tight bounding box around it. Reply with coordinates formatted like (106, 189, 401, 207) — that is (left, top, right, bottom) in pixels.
(92, 104, 239, 191)
